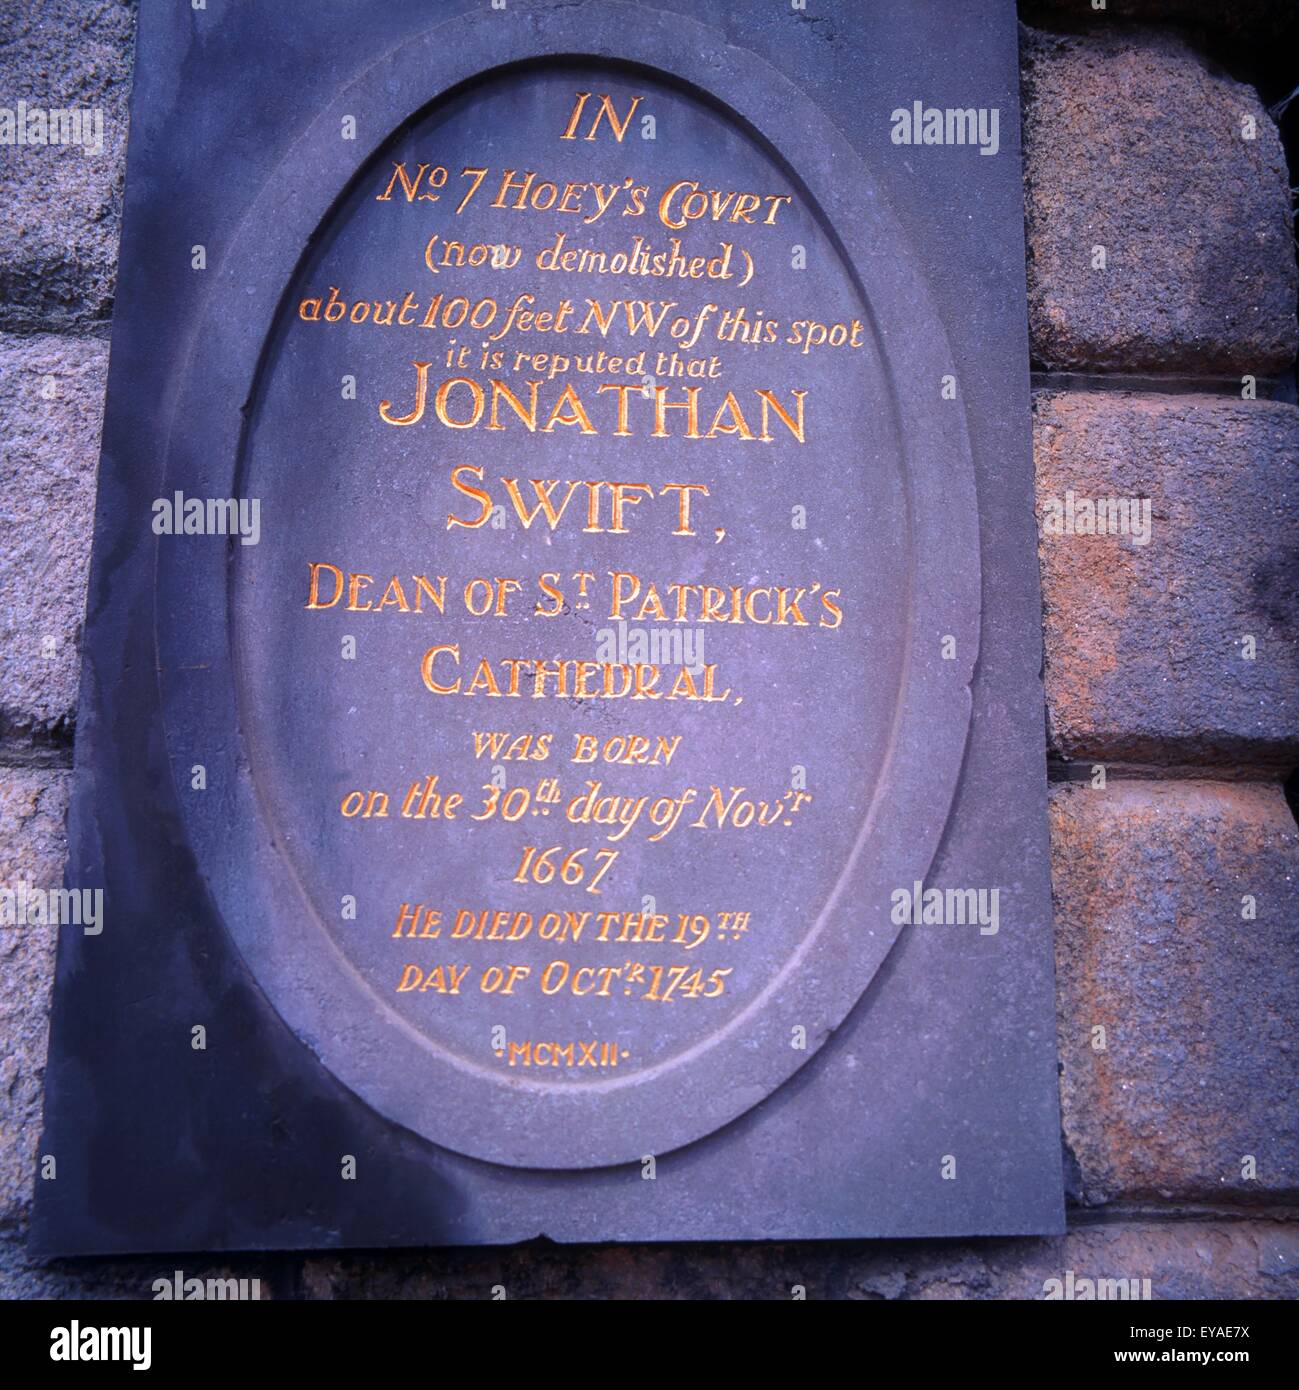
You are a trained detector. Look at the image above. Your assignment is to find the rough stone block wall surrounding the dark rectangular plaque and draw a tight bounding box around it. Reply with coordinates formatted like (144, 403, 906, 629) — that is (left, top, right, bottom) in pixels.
(0, 0, 1299, 1298)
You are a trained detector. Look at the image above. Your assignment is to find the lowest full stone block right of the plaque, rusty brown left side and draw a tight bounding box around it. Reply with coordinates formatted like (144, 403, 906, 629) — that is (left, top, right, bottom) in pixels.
(1052, 780, 1299, 1204)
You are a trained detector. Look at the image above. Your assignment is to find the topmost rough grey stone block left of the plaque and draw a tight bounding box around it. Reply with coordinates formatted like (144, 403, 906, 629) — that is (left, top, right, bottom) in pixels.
(0, 0, 135, 331)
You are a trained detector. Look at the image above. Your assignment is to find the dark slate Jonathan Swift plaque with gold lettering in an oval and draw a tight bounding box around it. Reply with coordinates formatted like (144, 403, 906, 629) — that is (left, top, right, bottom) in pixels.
(36, 0, 1061, 1254)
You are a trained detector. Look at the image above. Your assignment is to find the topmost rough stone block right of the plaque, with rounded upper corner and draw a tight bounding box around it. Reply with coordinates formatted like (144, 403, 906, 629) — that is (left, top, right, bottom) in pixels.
(1023, 31, 1296, 375)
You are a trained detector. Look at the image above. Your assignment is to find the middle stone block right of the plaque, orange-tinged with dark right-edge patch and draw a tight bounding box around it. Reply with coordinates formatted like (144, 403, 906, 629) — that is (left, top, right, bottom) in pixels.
(1034, 392, 1299, 770)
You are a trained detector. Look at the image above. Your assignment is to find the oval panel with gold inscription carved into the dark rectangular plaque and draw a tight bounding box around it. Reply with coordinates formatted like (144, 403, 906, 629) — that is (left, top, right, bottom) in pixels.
(163, 35, 977, 1168)
